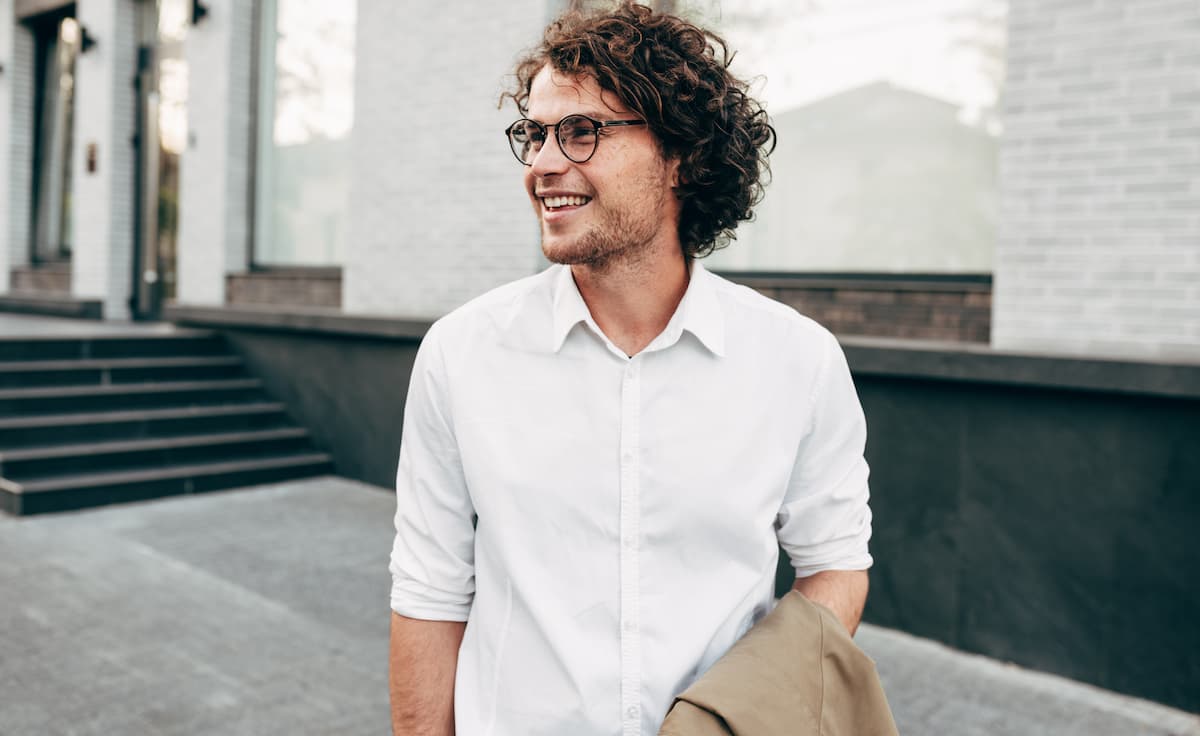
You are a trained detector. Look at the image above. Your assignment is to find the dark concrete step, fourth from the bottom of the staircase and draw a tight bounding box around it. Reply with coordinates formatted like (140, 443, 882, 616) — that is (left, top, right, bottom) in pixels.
(0, 378, 263, 417)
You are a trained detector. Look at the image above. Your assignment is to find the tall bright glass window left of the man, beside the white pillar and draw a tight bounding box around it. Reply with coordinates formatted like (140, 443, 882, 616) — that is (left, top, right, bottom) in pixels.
(254, 0, 356, 265)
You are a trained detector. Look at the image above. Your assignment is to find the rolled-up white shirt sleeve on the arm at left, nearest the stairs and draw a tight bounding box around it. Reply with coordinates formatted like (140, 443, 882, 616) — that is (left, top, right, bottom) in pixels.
(389, 324, 475, 621)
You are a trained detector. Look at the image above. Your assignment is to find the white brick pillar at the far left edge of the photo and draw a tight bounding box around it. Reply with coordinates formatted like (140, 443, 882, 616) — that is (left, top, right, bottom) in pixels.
(0, 11, 34, 288)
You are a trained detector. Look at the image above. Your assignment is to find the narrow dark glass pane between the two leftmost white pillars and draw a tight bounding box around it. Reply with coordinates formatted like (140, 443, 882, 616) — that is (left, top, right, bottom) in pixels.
(32, 18, 80, 263)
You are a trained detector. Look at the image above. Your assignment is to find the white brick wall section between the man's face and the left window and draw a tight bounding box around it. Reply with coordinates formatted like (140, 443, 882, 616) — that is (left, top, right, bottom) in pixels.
(343, 0, 547, 317)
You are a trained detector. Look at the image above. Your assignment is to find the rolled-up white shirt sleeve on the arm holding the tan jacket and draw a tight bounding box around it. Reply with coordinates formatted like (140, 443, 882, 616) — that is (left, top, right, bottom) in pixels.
(776, 333, 872, 578)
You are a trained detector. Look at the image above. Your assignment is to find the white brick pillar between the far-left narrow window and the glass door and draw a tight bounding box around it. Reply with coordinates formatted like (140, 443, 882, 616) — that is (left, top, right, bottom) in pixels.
(71, 0, 137, 319)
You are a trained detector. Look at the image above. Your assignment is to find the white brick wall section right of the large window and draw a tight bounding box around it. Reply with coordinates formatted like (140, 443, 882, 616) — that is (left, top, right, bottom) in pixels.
(992, 0, 1200, 360)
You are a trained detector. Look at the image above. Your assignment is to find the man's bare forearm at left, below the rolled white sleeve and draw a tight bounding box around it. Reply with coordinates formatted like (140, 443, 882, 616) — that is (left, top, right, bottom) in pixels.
(388, 611, 467, 736)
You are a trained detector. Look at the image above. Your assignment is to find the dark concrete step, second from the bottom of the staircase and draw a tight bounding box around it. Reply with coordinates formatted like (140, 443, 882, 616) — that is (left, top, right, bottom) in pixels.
(0, 426, 312, 483)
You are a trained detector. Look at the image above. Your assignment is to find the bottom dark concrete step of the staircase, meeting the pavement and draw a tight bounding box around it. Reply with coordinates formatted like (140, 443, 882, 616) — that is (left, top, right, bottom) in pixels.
(0, 451, 332, 515)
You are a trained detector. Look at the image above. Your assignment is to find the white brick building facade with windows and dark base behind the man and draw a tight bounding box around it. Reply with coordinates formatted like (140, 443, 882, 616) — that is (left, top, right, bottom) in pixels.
(0, 0, 1200, 710)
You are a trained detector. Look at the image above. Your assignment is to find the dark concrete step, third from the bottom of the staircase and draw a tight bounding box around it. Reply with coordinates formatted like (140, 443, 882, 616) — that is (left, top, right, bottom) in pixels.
(0, 401, 288, 450)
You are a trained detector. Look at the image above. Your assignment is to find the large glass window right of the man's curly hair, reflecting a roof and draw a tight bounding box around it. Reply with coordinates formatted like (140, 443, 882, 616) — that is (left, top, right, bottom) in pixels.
(700, 0, 1008, 273)
